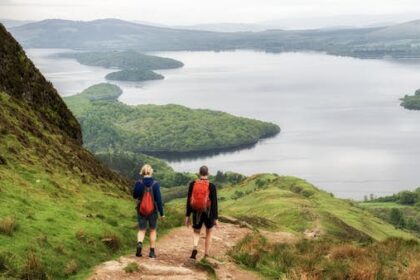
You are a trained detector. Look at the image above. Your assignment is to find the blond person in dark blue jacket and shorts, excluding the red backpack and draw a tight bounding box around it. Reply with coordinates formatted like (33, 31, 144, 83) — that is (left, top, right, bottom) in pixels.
(133, 164, 165, 258)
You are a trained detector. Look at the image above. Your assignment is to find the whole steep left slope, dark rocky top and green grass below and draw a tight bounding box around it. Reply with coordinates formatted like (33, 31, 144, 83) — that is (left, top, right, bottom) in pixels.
(0, 24, 172, 279)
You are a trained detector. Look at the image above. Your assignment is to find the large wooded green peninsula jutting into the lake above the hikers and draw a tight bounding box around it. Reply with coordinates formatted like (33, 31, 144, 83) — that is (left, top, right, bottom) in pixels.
(65, 84, 280, 154)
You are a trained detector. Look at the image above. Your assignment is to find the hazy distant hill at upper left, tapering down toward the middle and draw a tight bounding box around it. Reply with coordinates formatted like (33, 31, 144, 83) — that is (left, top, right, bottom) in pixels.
(10, 19, 233, 51)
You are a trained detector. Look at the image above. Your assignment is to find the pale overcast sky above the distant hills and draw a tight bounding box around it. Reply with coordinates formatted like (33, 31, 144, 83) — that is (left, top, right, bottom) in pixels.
(0, 0, 420, 25)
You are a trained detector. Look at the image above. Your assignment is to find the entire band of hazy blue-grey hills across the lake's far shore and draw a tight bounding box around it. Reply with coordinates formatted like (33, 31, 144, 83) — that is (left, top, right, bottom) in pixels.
(10, 19, 420, 58)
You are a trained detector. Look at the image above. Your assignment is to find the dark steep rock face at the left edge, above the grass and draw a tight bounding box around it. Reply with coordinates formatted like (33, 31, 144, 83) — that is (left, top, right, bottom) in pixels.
(0, 24, 82, 144)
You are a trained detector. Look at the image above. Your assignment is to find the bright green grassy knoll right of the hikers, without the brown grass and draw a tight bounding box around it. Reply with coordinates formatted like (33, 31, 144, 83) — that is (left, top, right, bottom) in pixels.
(172, 174, 413, 241)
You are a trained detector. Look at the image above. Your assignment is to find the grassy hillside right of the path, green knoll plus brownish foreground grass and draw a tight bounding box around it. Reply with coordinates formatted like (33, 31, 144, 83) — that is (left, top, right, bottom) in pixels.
(169, 174, 420, 280)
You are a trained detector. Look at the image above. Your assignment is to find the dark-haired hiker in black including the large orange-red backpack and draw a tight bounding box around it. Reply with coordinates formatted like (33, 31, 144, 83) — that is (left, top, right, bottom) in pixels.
(185, 166, 218, 259)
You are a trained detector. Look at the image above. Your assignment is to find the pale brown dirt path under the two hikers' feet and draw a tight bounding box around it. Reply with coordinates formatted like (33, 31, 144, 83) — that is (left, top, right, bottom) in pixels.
(90, 223, 259, 280)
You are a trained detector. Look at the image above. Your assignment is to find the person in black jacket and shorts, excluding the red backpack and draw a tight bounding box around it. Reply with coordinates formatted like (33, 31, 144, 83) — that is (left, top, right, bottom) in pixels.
(185, 166, 218, 259)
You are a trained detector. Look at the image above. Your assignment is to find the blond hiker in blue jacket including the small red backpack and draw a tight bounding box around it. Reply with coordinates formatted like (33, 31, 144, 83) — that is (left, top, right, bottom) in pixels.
(133, 164, 165, 258)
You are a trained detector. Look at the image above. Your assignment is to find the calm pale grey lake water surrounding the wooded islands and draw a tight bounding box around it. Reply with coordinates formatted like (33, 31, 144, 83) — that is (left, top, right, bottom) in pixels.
(28, 49, 420, 199)
